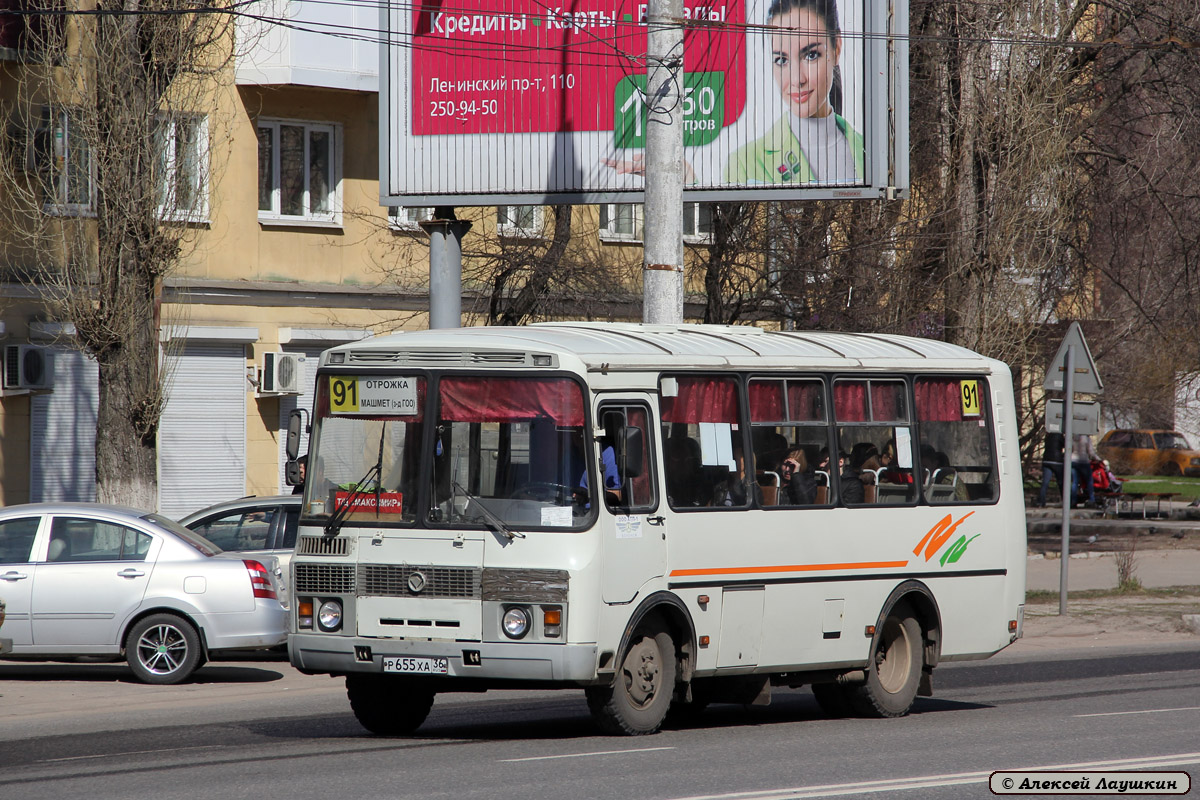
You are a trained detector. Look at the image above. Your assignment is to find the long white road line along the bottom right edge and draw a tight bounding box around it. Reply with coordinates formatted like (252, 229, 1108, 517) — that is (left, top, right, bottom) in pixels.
(674, 752, 1200, 800)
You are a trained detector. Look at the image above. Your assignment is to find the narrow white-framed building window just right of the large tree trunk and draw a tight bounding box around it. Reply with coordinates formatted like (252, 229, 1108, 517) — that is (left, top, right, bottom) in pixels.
(155, 114, 209, 222)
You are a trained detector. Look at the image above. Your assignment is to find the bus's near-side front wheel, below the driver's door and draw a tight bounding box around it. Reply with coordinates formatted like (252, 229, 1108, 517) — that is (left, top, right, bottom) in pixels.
(586, 624, 676, 736)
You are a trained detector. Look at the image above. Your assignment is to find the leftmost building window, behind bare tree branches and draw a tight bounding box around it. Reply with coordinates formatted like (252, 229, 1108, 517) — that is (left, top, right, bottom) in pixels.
(34, 107, 94, 213)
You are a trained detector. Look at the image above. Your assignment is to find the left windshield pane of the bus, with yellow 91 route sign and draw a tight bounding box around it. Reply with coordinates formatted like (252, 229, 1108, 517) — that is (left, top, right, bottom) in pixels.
(305, 375, 426, 525)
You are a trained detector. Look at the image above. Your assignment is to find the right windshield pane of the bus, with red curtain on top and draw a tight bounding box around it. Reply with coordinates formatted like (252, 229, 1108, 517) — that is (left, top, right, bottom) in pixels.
(430, 377, 595, 530)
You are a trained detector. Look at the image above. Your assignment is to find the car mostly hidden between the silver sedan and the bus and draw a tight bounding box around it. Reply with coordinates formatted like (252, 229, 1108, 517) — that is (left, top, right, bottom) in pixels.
(179, 494, 301, 608)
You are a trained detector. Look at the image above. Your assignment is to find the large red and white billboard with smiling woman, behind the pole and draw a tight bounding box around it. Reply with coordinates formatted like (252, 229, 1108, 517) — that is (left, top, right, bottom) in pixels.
(379, 0, 907, 206)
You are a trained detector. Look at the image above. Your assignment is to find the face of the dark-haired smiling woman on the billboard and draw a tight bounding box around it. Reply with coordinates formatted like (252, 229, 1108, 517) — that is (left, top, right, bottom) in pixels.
(770, 8, 841, 116)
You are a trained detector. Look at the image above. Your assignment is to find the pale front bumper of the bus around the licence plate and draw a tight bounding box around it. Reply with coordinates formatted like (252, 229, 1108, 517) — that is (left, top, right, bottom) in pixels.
(288, 633, 596, 682)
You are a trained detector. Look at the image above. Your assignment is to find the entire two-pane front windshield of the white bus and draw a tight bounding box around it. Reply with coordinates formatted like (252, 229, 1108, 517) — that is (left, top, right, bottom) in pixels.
(305, 375, 593, 535)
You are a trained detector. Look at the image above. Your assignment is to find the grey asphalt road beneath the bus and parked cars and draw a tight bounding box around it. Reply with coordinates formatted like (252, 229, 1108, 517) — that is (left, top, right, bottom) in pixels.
(0, 642, 1200, 800)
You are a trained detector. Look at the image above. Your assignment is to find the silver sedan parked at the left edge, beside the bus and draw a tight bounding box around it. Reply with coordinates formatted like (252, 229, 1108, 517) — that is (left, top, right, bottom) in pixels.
(0, 503, 287, 684)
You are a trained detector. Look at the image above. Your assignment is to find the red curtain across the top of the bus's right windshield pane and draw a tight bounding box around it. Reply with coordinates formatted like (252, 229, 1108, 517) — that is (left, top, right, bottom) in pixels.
(438, 378, 583, 427)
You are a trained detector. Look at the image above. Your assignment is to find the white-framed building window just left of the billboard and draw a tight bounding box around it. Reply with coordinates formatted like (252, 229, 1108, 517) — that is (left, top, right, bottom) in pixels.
(258, 120, 342, 224)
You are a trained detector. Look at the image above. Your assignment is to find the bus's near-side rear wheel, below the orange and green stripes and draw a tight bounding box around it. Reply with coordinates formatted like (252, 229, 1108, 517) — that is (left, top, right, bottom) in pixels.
(852, 602, 924, 717)
